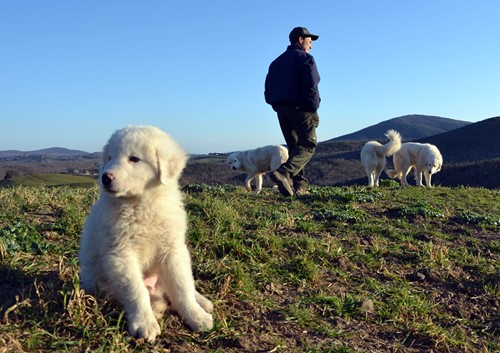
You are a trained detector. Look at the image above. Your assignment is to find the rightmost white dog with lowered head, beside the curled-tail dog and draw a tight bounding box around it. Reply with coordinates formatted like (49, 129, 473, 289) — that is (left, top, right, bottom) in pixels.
(386, 142, 443, 187)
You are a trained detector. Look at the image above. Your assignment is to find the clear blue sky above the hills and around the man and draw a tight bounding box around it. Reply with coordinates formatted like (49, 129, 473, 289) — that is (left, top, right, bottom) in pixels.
(0, 0, 500, 153)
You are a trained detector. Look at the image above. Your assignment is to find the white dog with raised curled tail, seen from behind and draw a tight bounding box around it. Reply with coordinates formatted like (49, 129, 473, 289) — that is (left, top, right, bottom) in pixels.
(361, 130, 401, 186)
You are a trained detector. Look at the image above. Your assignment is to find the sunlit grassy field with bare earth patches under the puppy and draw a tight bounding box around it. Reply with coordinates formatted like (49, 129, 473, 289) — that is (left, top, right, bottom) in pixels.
(0, 182, 500, 353)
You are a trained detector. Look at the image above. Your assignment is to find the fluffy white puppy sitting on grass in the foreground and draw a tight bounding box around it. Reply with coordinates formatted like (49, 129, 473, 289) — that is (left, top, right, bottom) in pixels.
(79, 126, 213, 341)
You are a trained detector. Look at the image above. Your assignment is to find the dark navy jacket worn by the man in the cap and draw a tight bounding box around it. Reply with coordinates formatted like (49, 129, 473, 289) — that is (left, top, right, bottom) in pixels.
(264, 44, 321, 112)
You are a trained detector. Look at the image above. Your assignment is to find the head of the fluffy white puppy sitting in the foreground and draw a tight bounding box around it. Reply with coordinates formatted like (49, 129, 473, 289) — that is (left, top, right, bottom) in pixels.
(99, 126, 187, 197)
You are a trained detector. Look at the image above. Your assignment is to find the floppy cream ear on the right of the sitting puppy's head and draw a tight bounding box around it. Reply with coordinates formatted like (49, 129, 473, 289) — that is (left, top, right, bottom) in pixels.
(156, 145, 188, 184)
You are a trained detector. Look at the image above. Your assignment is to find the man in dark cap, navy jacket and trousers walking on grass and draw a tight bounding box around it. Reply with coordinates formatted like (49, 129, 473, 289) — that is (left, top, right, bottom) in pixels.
(264, 27, 321, 196)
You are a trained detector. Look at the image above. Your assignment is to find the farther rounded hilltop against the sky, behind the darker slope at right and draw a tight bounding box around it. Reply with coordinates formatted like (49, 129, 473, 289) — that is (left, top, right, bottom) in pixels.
(324, 114, 472, 142)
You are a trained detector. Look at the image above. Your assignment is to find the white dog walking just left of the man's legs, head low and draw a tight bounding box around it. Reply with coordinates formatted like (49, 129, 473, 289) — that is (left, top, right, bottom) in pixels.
(227, 145, 288, 194)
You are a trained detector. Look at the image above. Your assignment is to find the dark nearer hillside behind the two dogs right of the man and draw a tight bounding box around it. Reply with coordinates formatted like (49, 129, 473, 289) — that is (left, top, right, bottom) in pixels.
(307, 117, 500, 188)
